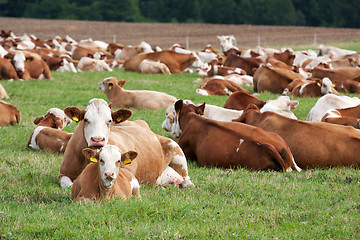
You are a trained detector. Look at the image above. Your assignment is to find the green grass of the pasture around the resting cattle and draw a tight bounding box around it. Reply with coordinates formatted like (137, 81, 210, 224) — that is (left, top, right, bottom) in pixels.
(0, 55, 360, 239)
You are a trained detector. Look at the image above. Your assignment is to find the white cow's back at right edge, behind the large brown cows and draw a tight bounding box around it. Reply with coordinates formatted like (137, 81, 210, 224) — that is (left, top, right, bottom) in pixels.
(306, 94, 360, 122)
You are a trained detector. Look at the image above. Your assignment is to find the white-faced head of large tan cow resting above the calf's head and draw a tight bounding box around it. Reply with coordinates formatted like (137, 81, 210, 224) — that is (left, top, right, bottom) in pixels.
(64, 98, 132, 147)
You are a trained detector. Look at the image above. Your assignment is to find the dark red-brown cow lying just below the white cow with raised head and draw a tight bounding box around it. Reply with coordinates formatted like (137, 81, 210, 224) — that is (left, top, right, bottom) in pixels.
(224, 54, 263, 76)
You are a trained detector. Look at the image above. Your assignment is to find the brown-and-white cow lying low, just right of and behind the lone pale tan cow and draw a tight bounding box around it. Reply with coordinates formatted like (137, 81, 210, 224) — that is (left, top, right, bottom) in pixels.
(196, 79, 250, 96)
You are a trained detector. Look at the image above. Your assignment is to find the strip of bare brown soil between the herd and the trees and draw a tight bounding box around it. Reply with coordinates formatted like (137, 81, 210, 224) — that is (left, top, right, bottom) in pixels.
(0, 17, 360, 49)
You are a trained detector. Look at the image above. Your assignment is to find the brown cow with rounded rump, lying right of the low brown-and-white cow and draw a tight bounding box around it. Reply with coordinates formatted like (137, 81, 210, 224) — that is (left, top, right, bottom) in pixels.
(253, 64, 305, 94)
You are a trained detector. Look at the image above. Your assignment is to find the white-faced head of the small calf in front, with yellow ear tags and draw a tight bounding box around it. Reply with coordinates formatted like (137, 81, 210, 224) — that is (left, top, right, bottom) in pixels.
(82, 145, 137, 188)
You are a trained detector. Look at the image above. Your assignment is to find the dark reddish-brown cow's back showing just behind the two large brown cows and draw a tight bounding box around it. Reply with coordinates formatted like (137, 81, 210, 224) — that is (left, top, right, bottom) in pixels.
(224, 92, 266, 110)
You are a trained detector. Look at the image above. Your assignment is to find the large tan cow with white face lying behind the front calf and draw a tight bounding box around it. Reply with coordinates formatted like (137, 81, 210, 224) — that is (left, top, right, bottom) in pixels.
(59, 99, 193, 188)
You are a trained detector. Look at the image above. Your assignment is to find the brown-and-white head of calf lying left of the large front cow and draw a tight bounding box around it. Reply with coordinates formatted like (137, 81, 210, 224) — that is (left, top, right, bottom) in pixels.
(34, 108, 72, 129)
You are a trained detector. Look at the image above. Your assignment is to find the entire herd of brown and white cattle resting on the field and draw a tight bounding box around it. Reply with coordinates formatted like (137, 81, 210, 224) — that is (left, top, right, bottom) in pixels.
(0, 31, 360, 200)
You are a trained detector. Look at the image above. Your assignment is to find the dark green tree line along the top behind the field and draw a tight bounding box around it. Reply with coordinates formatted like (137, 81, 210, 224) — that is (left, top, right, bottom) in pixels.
(0, 0, 360, 28)
